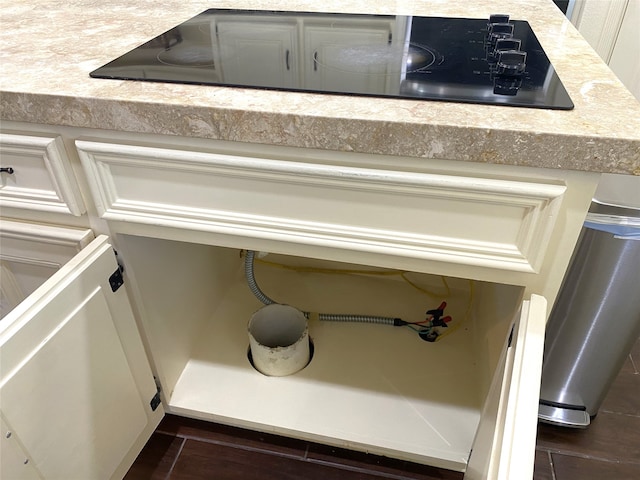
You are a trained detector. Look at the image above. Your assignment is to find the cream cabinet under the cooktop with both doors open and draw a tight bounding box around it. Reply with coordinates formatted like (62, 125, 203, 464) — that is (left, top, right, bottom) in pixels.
(0, 123, 598, 479)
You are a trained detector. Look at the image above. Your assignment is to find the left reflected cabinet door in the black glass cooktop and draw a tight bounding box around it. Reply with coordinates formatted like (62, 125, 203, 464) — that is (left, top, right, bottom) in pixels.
(216, 19, 299, 87)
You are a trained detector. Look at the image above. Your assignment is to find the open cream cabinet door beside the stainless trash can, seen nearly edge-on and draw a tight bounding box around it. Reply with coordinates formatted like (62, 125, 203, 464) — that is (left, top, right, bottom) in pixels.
(464, 295, 547, 480)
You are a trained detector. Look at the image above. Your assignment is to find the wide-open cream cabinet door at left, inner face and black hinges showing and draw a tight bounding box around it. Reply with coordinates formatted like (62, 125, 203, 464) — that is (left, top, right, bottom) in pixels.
(0, 236, 163, 480)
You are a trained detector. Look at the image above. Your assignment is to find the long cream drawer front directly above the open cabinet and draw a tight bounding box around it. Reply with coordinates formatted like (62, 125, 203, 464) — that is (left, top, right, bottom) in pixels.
(76, 141, 565, 272)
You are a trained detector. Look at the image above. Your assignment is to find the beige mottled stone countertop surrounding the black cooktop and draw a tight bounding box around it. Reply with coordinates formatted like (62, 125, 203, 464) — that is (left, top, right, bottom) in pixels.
(0, 0, 640, 175)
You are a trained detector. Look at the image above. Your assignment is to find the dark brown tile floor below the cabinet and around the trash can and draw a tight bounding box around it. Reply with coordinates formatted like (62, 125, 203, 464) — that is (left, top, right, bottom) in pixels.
(126, 340, 640, 480)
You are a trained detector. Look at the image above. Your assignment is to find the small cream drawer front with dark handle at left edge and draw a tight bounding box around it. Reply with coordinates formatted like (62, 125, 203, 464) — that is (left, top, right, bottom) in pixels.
(0, 133, 85, 216)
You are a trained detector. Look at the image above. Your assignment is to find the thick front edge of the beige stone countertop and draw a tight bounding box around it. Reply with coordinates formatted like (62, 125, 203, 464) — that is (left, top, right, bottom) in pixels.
(0, 92, 640, 176)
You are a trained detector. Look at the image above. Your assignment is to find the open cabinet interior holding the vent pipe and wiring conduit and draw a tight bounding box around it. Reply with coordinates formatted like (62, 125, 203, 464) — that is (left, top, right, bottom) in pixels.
(116, 234, 524, 471)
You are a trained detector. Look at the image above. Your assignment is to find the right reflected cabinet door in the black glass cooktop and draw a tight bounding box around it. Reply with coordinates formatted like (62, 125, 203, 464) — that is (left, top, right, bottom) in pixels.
(304, 25, 392, 93)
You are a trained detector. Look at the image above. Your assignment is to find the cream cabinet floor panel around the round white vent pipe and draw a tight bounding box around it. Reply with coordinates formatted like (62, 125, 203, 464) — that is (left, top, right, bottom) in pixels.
(169, 266, 482, 471)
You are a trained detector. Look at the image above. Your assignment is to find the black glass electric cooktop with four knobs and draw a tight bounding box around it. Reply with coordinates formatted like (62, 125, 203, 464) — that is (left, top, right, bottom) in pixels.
(91, 9, 573, 110)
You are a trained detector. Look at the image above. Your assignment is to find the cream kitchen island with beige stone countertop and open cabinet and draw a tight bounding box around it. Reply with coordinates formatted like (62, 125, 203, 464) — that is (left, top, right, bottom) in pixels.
(0, 0, 640, 479)
